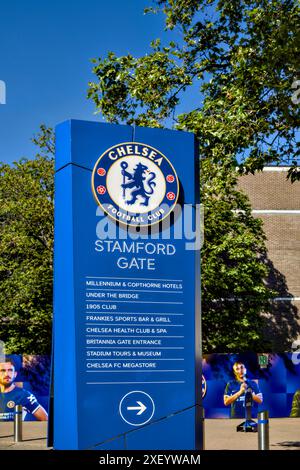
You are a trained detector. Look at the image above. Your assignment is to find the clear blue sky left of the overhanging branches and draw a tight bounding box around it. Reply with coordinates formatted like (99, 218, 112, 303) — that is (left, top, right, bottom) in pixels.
(0, 0, 171, 163)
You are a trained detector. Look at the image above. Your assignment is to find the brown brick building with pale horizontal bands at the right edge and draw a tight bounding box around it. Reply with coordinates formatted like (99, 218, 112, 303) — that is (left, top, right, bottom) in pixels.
(239, 167, 300, 351)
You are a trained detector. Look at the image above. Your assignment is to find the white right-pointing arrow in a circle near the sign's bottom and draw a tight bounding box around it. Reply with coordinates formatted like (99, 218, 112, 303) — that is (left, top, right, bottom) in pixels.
(119, 390, 155, 426)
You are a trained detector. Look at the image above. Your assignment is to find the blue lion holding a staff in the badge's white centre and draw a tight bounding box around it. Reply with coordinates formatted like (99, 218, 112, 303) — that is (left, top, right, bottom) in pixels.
(121, 162, 156, 206)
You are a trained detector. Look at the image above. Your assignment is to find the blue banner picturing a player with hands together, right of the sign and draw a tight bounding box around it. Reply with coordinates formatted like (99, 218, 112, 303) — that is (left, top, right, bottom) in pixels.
(202, 353, 300, 418)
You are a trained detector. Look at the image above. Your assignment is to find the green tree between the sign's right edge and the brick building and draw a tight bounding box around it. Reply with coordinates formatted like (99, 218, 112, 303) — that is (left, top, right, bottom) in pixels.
(201, 160, 274, 352)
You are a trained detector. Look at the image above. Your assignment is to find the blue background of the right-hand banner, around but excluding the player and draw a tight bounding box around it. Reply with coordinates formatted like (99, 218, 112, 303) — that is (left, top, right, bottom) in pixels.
(202, 352, 300, 418)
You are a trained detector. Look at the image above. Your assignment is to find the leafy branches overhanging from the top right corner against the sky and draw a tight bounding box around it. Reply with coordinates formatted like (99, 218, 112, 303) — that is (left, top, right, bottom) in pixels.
(88, 0, 300, 179)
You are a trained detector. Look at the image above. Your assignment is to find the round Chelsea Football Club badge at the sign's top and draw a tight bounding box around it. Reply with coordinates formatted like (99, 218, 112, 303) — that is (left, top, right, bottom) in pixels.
(92, 142, 179, 226)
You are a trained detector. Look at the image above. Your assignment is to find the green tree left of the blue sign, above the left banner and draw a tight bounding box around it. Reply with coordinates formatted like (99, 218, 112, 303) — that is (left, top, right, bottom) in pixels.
(0, 126, 54, 354)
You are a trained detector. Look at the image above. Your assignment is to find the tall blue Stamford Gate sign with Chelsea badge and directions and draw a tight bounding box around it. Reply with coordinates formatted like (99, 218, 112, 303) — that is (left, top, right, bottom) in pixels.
(54, 120, 202, 450)
